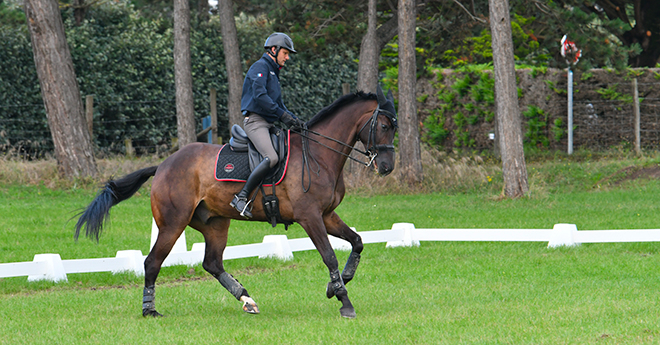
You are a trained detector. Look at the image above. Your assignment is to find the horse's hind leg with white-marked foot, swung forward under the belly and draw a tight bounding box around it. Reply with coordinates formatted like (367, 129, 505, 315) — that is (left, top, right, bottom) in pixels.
(190, 217, 259, 314)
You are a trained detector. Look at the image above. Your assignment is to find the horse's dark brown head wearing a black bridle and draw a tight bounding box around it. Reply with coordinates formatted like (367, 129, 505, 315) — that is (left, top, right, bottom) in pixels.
(358, 86, 398, 176)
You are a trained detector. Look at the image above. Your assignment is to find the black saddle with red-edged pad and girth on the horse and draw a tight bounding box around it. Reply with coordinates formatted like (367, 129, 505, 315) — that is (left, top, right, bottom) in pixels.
(215, 125, 292, 229)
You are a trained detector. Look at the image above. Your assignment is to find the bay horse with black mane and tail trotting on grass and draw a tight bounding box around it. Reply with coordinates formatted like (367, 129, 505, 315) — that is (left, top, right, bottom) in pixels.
(75, 87, 397, 318)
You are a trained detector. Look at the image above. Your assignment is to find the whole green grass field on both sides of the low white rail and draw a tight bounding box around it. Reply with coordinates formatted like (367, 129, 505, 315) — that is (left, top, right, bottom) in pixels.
(0, 155, 660, 344)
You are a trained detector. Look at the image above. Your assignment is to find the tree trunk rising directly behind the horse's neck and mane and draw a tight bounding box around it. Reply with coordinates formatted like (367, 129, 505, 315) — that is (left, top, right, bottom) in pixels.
(357, 0, 380, 93)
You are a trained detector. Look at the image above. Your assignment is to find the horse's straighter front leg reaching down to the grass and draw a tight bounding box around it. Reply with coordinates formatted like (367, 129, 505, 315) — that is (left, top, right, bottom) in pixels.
(299, 219, 355, 318)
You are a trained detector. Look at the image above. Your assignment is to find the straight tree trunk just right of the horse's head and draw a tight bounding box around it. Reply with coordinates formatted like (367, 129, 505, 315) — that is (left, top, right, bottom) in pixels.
(398, 0, 422, 183)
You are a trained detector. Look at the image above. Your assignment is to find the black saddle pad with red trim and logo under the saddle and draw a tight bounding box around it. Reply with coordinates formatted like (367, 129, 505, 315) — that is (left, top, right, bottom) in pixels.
(215, 144, 289, 187)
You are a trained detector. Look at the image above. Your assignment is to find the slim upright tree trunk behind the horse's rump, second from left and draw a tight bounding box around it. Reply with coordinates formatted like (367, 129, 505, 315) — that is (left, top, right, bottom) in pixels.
(174, 0, 197, 147)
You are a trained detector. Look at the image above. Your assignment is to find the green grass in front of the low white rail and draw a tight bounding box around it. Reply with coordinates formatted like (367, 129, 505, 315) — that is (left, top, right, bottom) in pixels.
(0, 242, 660, 344)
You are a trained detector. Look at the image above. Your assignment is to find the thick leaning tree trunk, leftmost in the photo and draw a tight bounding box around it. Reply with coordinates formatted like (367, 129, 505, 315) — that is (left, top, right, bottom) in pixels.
(24, 0, 97, 178)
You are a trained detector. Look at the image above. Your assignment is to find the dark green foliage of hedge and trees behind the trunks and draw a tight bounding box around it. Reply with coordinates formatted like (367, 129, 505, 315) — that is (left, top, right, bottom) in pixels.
(0, 0, 660, 157)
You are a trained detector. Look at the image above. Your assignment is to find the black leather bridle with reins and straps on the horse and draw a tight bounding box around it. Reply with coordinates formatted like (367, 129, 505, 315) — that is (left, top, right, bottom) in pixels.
(292, 104, 399, 193)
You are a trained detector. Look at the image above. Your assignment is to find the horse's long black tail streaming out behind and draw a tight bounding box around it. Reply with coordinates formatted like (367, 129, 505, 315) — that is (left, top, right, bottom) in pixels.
(74, 166, 158, 241)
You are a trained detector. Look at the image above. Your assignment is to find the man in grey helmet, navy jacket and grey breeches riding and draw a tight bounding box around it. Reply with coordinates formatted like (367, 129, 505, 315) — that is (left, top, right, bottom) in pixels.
(230, 32, 304, 218)
